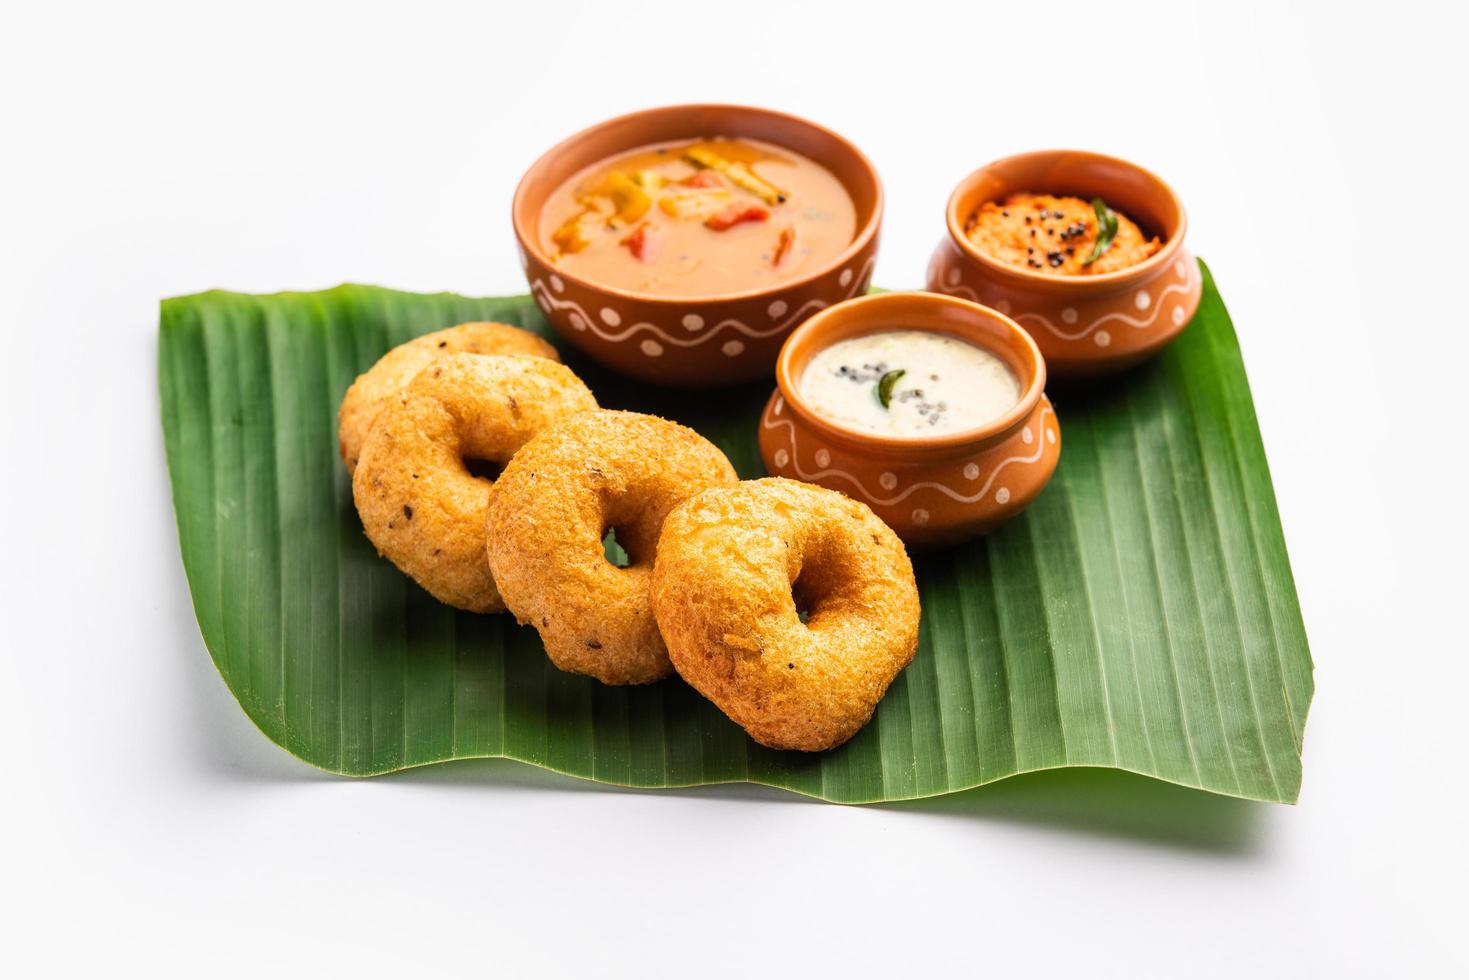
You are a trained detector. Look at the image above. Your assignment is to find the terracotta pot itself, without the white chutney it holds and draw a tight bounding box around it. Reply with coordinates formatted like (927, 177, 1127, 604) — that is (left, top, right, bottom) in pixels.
(759, 292, 1061, 548)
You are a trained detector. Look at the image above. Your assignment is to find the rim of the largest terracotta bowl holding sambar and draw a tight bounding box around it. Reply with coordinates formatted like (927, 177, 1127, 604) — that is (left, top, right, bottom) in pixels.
(510, 103, 884, 306)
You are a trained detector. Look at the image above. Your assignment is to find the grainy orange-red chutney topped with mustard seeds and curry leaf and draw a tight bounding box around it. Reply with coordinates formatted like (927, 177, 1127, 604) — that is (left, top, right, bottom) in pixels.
(964, 192, 1163, 276)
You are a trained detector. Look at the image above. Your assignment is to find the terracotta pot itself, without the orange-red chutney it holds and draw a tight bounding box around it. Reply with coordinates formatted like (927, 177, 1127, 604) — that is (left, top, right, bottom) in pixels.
(928, 150, 1203, 379)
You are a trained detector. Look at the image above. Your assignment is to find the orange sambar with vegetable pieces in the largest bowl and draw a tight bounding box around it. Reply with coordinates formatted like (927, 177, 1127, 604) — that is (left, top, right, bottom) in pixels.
(538, 140, 856, 298)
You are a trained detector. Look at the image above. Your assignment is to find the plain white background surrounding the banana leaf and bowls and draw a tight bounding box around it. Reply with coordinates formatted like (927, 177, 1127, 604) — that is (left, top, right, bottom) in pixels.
(0, 0, 1469, 977)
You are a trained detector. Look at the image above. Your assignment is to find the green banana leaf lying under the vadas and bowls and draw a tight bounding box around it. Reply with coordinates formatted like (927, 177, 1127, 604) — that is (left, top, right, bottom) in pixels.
(159, 264, 1312, 802)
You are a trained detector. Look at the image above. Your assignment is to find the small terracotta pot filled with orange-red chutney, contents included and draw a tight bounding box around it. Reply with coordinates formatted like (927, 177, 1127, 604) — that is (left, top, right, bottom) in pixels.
(927, 150, 1203, 379)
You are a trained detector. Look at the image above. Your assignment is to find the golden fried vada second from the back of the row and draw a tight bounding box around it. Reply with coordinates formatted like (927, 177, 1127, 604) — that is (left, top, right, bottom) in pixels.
(353, 354, 596, 613)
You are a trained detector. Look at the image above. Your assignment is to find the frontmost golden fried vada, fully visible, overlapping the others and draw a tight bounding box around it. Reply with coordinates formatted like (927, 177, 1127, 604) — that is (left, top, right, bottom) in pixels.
(652, 479, 918, 751)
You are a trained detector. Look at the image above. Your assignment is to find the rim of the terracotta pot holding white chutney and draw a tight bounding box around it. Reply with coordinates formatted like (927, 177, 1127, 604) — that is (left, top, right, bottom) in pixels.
(776, 289, 1046, 455)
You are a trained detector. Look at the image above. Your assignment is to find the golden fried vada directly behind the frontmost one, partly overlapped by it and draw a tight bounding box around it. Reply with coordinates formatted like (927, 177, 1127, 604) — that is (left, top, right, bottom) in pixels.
(488, 411, 736, 685)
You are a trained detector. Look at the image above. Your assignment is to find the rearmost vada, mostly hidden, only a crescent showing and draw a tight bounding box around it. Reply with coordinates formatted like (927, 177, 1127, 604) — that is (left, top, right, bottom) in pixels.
(336, 323, 561, 473)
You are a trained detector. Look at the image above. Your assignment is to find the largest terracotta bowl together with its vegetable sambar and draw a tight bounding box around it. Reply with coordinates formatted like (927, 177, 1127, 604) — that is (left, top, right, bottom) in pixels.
(511, 104, 883, 388)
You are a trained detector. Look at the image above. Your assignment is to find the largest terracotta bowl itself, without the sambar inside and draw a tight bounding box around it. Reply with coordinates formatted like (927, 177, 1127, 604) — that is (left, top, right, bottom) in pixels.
(511, 106, 883, 388)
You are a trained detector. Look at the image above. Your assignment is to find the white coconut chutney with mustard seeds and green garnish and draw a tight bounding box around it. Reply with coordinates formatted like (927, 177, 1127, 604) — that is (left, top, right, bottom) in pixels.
(799, 331, 1019, 438)
